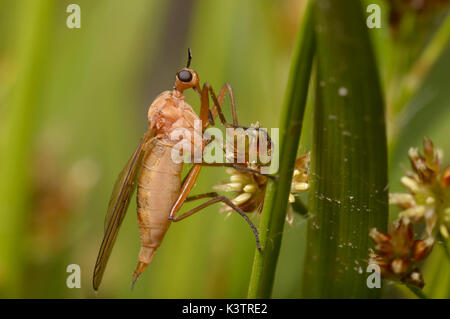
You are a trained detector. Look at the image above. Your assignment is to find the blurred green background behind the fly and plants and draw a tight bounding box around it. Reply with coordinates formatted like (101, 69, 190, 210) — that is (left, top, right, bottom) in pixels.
(0, 0, 450, 298)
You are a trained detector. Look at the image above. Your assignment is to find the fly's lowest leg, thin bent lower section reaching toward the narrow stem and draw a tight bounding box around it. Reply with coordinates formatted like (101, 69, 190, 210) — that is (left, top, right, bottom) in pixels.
(169, 192, 261, 250)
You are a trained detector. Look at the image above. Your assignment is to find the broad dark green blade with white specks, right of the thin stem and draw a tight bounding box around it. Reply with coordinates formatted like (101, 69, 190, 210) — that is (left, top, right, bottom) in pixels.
(303, 0, 388, 298)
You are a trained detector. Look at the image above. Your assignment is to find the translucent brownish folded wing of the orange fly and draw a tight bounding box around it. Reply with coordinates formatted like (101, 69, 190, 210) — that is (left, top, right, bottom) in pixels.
(93, 131, 152, 290)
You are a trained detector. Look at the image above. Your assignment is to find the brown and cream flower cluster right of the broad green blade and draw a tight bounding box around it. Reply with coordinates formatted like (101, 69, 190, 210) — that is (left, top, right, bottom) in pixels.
(369, 138, 450, 288)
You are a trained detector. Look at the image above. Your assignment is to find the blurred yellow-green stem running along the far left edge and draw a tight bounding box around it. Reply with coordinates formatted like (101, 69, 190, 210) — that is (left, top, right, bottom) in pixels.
(0, 0, 53, 298)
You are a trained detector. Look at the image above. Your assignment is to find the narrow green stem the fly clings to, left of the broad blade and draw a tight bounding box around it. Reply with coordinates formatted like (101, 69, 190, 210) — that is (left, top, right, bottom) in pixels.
(248, 2, 314, 298)
